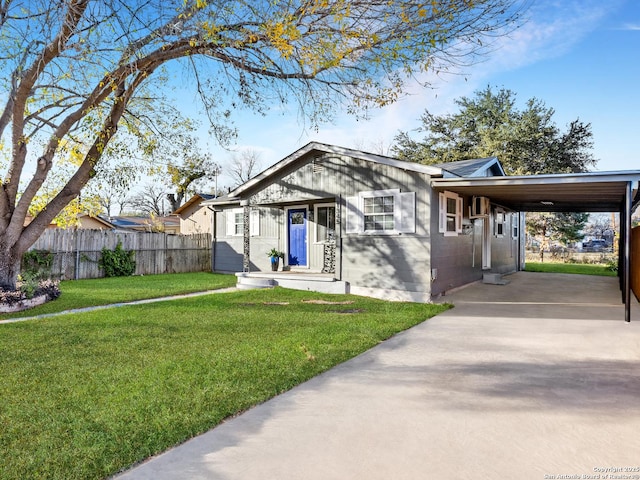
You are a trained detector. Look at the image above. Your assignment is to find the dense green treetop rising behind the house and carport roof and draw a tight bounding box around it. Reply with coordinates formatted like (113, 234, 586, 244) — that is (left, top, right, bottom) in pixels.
(393, 86, 596, 175)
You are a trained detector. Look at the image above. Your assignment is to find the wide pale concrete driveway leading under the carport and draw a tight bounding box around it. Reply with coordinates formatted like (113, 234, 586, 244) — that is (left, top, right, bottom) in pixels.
(118, 272, 640, 480)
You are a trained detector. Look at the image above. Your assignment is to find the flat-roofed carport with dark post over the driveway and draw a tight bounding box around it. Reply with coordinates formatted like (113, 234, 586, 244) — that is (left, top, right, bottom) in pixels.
(431, 170, 640, 322)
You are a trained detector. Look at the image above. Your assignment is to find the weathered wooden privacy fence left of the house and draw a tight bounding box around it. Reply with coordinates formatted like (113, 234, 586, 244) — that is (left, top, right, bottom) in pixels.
(31, 229, 211, 280)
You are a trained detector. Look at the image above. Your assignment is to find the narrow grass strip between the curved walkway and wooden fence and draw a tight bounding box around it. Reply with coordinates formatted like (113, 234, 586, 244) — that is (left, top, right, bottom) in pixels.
(0, 272, 236, 320)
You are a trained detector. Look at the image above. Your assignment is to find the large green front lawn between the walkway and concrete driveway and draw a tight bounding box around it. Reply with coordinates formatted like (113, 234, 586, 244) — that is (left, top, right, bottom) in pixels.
(0, 286, 448, 480)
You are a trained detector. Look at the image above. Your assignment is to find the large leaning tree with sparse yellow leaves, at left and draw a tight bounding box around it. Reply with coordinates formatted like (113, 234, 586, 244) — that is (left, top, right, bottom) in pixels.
(0, 0, 521, 287)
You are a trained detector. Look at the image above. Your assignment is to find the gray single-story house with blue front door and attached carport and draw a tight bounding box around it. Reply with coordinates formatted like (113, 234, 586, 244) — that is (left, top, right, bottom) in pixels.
(201, 142, 640, 318)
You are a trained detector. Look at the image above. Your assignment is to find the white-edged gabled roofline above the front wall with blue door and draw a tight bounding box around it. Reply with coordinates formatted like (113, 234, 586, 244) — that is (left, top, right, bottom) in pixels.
(211, 142, 442, 204)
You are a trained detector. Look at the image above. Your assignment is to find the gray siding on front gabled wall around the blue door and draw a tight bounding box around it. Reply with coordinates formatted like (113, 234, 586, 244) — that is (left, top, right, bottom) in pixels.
(212, 154, 438, 296)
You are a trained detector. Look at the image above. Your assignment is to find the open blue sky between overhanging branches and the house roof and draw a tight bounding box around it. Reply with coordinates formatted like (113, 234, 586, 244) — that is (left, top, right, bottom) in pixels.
(206, 0, 640, 185)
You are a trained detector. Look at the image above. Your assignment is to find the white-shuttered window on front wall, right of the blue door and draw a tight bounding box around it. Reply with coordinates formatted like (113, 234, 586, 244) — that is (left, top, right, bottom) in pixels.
(345, 189, 416, 235)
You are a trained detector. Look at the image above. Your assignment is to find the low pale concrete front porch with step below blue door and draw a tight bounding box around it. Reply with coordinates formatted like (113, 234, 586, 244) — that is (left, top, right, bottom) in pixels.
(236, 271, 349, 294)
